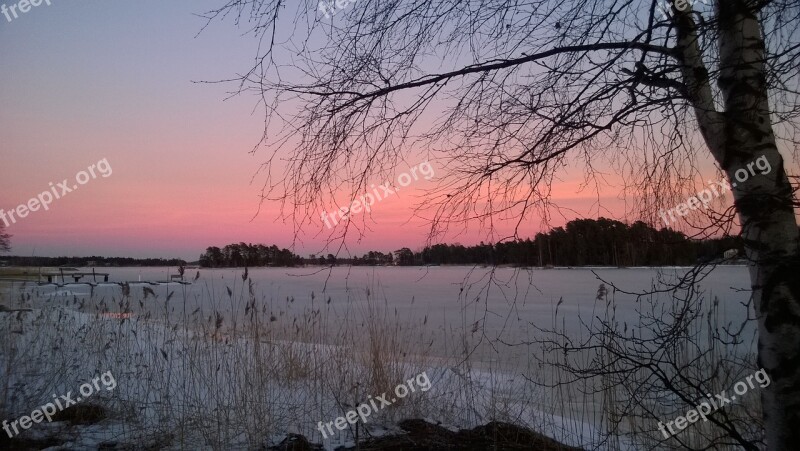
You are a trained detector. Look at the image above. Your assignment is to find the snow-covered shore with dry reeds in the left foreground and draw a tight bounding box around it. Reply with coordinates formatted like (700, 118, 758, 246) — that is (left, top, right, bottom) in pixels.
(0, 306, 620, 449)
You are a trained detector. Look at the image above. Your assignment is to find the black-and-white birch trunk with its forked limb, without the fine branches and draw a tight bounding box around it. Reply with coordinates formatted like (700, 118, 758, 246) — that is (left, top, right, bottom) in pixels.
(677, 0, 800, 451)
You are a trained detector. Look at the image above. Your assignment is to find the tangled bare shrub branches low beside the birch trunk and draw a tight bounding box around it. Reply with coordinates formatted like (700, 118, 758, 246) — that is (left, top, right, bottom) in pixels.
(524, 265, 769, 451)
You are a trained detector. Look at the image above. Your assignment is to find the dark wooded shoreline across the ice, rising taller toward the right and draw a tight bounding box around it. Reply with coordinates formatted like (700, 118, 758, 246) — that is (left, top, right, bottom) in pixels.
(199, 218, 742, 268)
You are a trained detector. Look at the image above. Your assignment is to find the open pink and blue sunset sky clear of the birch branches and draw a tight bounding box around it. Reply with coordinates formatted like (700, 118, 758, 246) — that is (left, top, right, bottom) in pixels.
(0, 0, 700, 261)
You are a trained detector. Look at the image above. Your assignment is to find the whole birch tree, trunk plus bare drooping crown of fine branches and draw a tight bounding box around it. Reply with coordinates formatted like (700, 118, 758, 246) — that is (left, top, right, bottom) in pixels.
(209, 0, 800, 450)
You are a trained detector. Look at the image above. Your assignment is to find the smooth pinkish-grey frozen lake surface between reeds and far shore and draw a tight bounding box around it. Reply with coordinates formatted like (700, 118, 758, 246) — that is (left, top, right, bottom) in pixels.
(18, 266, 749, 366)
